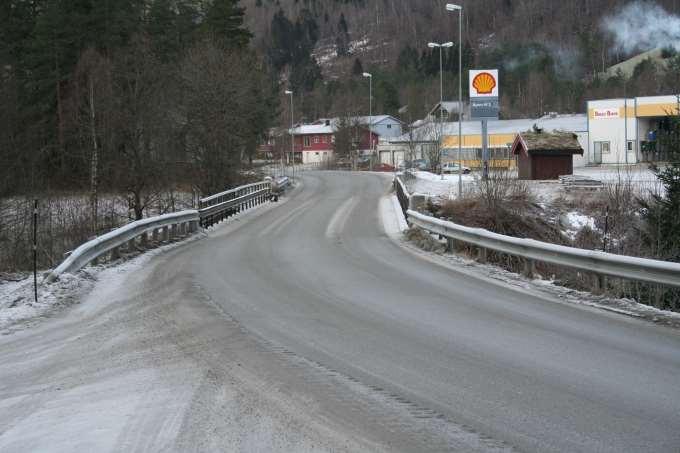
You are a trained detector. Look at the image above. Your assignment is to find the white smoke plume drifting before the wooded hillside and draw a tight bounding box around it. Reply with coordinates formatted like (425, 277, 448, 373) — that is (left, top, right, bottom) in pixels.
(602, 2, 680, 53)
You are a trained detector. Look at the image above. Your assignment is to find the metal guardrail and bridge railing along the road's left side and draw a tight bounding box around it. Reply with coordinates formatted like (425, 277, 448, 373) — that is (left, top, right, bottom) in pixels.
(45, 177, 282, 282)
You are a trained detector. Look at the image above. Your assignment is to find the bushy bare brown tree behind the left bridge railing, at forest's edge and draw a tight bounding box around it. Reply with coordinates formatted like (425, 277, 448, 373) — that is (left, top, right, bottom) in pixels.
(180, 41, 269, 193)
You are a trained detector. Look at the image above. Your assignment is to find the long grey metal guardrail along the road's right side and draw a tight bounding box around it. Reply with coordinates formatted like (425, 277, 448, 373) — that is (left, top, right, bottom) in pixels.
(407, 210, 680, 287)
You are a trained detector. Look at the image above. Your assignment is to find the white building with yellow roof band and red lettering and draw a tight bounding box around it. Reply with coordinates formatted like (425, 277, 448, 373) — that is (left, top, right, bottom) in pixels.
(583, 95, 680, 165)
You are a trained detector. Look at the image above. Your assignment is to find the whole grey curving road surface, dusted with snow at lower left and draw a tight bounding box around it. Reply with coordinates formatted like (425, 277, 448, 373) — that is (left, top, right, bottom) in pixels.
(0, 173, 680, 452)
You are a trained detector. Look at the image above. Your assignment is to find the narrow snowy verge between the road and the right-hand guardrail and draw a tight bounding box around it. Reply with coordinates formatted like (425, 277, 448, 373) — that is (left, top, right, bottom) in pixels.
(380, 195, 680, 328)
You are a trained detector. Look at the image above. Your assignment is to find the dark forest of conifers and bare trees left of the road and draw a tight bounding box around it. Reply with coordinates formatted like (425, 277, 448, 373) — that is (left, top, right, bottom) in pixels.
(0, 0, 276, 200)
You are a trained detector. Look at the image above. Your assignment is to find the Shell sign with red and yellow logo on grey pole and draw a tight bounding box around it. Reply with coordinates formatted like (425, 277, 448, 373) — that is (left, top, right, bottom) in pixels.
(470, 69, 500, 179)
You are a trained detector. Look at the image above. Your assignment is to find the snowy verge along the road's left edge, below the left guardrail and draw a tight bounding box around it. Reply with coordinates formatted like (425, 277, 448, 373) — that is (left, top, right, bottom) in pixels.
(0, 192, 288, 335)
